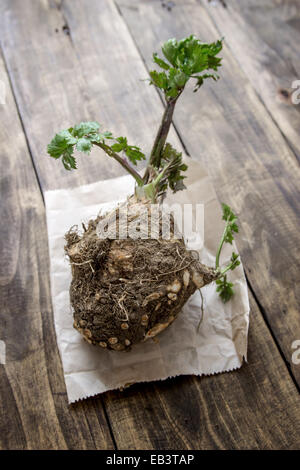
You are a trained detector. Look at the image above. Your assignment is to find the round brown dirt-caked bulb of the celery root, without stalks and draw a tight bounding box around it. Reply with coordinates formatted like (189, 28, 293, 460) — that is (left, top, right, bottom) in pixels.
(65, 196, 216, 351)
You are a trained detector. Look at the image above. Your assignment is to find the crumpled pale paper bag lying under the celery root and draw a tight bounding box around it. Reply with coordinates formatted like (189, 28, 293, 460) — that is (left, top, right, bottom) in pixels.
(45, 158, 249, 403)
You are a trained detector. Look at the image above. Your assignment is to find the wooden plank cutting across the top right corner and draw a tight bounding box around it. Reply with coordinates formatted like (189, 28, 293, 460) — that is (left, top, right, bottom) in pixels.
(205, 0, 300, 160)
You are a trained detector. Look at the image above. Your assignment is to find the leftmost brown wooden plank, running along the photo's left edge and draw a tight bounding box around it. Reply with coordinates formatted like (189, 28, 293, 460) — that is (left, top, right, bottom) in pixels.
(0, 49, 113, 449)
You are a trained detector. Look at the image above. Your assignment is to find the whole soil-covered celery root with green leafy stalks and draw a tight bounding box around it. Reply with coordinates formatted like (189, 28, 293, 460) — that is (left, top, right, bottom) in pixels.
(48, 36, 239, 351)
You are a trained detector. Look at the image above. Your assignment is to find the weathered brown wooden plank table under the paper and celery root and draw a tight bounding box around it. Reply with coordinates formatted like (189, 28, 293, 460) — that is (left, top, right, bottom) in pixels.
(0, 0, 300, 449)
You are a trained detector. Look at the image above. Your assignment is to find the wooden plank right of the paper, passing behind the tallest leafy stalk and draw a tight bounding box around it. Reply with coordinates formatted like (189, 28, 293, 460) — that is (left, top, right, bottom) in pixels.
(119, 0, 300, 383)
